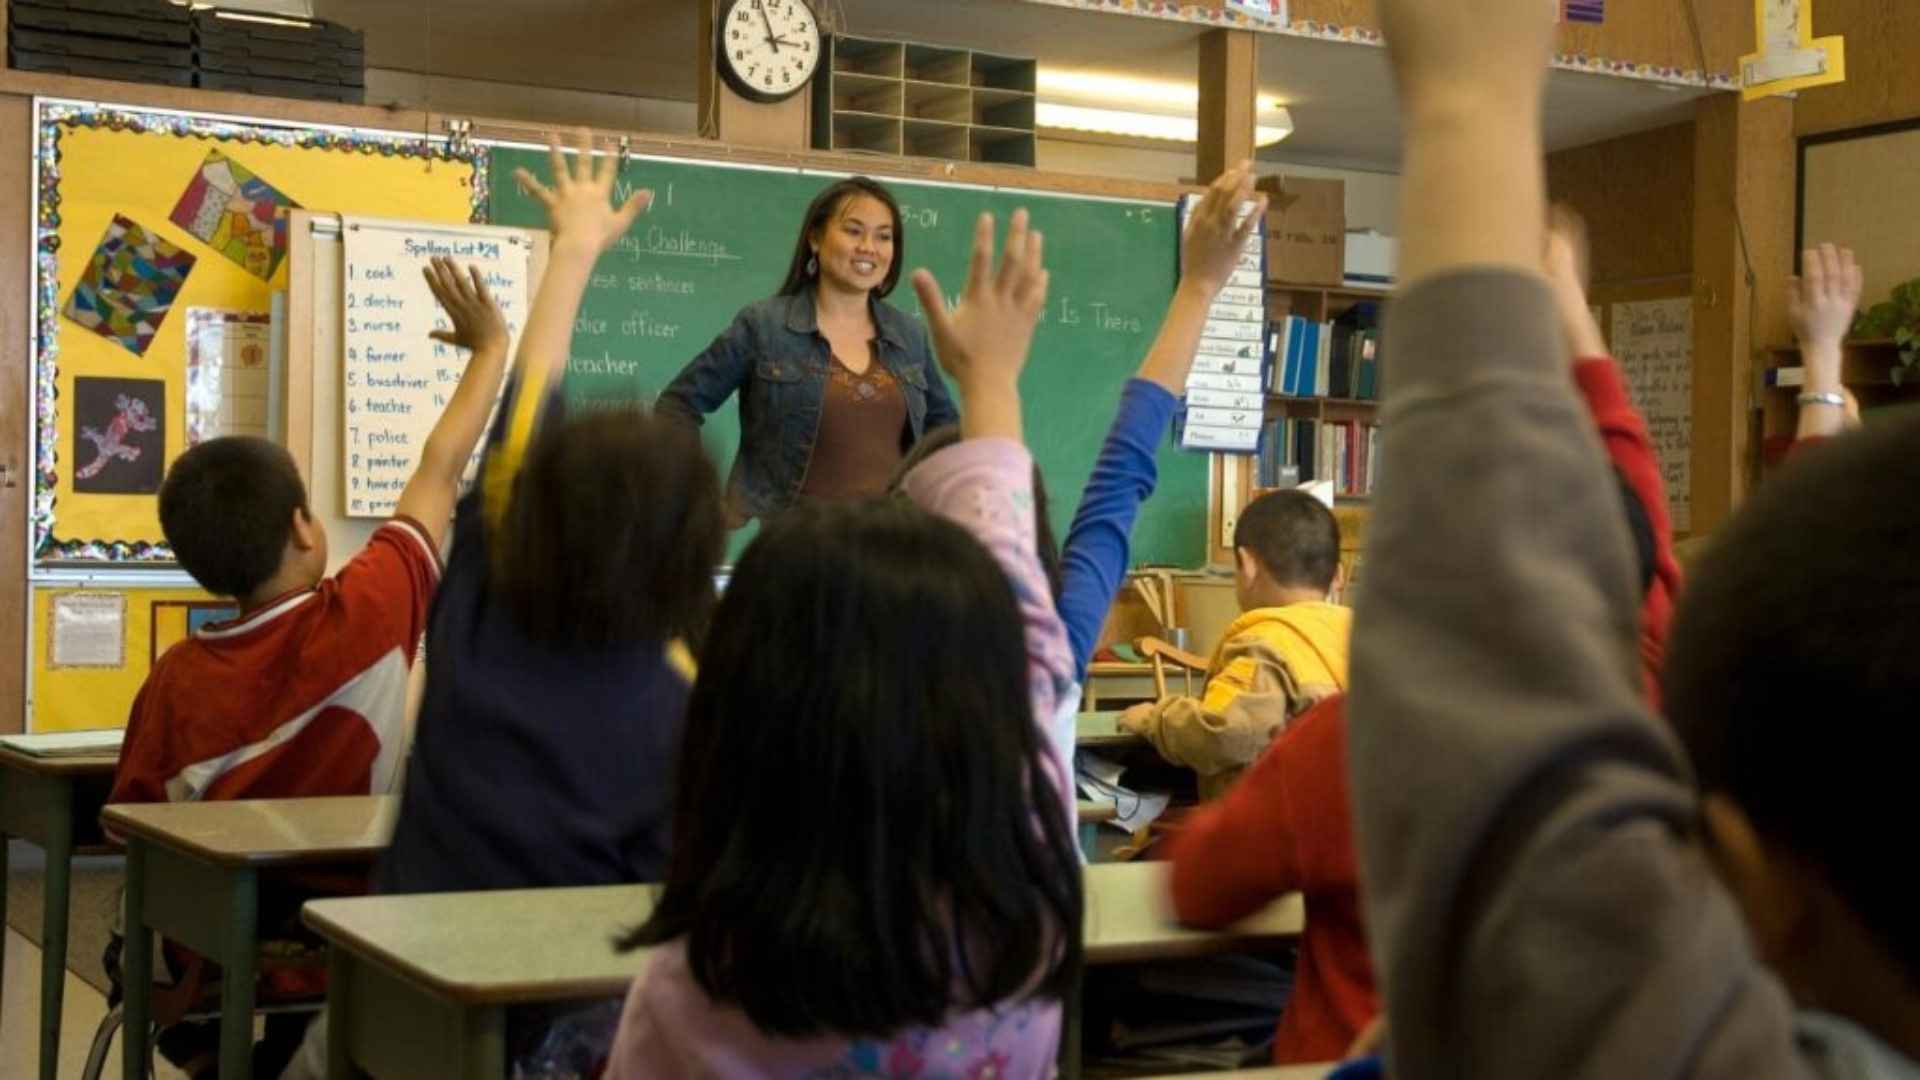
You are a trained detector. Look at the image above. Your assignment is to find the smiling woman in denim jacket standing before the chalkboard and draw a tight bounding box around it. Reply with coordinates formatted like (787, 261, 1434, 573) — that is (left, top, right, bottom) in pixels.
(657, 177, 960, 528)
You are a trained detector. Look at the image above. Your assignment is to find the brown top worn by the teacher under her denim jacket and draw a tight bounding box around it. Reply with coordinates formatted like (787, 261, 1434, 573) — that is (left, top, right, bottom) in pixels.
(801, 356, 906, 500)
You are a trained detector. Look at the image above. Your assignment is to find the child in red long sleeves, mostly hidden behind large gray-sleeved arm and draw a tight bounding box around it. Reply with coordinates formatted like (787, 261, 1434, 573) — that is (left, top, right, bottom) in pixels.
(1167, 208, 1680, 1065)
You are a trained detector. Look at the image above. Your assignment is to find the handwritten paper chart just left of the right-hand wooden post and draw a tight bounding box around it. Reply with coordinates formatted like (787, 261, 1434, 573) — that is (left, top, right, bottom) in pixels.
(1613, 296, 1693, 532)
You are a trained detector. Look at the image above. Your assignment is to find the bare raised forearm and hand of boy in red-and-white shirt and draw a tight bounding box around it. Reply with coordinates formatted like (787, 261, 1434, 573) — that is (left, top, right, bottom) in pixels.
(394, 258, 509, 548)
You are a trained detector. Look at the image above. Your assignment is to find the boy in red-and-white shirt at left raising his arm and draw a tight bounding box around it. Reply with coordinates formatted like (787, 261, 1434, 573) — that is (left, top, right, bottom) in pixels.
(108, 259, 507, 1076)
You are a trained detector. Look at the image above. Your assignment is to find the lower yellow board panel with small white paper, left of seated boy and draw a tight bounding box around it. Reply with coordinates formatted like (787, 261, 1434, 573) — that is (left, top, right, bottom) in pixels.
(29, 584, 228, 732)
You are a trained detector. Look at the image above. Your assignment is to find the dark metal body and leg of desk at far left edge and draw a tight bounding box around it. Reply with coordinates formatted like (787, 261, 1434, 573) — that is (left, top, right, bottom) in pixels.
(0, 746, 119, 1080)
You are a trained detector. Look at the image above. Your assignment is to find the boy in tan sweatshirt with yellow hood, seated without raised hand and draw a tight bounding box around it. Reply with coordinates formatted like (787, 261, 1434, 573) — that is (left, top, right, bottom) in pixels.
(1119, 492, 1354, 799)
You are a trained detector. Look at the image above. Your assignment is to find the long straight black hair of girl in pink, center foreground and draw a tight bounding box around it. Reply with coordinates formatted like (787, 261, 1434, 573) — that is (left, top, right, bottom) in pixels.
(626, 500, 1081, 1038)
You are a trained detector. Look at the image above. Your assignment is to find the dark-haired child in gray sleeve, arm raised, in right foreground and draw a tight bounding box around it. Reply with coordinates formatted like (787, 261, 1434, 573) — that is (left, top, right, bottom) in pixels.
(1350, 0, 1920, 1080)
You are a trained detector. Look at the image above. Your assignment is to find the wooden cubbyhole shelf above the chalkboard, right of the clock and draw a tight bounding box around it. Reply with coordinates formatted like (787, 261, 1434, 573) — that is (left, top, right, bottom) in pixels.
(814, 35, 1039, 167)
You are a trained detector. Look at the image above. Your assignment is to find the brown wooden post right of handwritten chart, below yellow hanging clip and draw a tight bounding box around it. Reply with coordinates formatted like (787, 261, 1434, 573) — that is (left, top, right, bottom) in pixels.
(1690, 94, 1795, 534)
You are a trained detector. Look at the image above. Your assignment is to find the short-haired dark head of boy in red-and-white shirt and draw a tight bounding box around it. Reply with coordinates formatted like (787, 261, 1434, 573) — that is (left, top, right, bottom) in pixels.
(159, 436, 307, 598)
